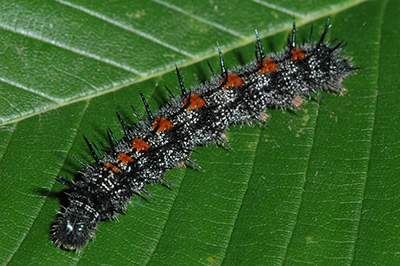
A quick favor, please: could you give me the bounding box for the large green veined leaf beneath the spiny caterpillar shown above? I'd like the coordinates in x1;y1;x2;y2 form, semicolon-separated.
0;0;400;265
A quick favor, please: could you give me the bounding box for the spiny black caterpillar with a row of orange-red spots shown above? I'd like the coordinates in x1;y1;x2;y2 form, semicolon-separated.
50;19;356;250
